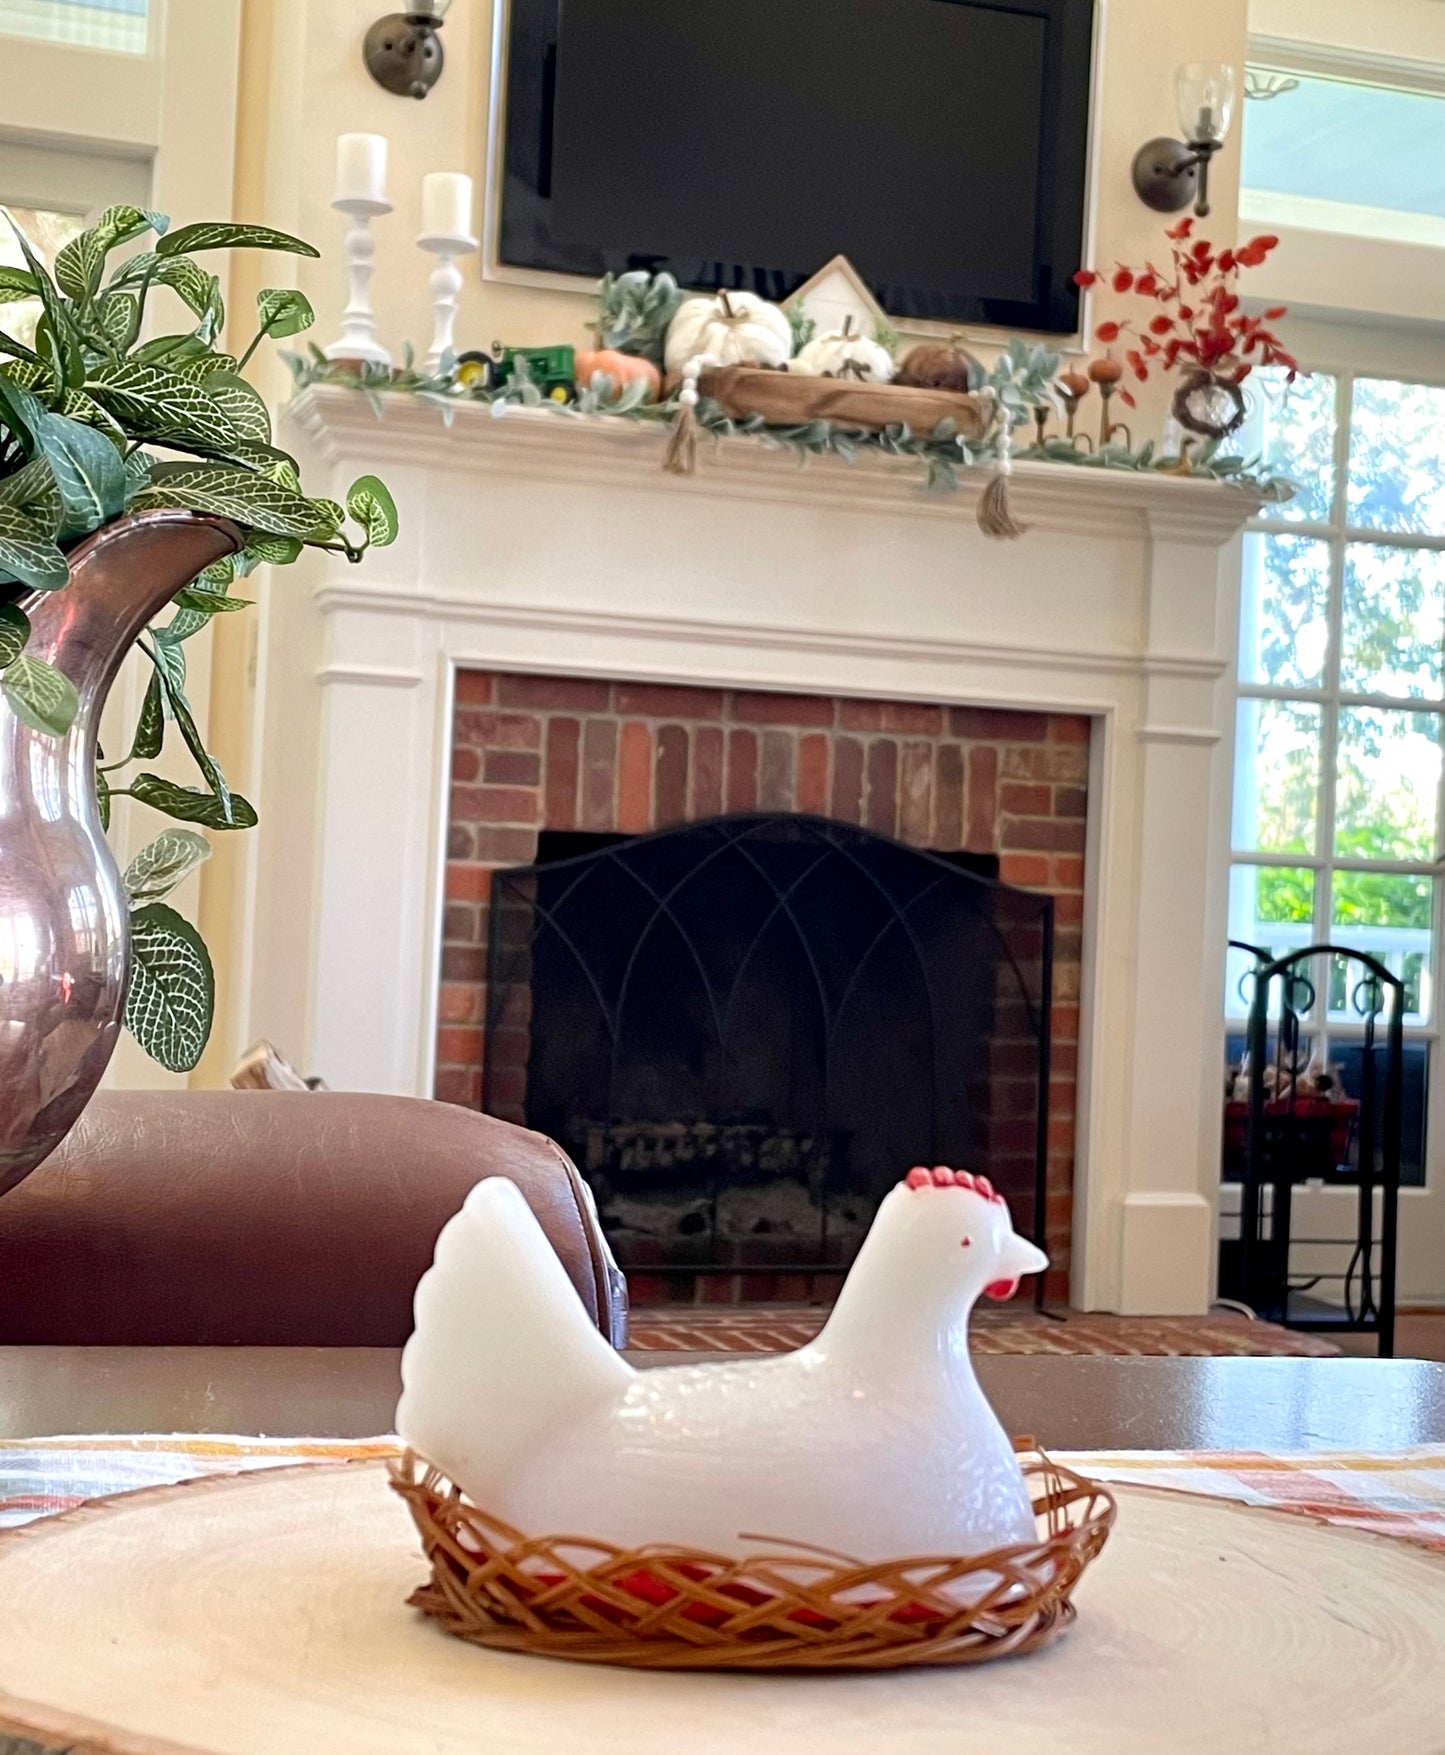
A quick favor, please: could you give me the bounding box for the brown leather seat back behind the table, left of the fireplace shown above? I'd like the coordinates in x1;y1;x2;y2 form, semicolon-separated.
0;1092;627;1346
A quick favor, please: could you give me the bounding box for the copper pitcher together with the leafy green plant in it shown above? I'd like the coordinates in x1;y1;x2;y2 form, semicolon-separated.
0;207;397;1193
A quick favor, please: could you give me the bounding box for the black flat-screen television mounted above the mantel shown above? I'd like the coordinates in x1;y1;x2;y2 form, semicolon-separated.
497;0;1094;333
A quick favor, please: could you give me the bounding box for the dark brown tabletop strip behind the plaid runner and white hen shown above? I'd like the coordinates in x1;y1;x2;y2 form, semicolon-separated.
0;1346;1445;1450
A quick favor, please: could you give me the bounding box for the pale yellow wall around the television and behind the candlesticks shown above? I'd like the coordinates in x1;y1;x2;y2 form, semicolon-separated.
195;0;1247;1083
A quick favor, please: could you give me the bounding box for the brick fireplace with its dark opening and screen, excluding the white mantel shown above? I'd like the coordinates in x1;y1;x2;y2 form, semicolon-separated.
435;670;1089;1304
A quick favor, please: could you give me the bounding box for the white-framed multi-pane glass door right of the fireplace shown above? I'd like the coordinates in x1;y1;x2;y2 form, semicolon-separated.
1226;372;1445;1179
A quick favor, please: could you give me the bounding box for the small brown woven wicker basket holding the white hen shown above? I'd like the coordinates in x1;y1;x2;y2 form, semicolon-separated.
392;1439;1115;1669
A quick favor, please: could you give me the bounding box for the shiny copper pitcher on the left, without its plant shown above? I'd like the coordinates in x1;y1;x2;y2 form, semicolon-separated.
0;511;241;1195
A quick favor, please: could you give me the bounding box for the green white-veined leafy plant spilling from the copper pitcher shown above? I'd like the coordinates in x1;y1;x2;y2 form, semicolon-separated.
0;207;397;1071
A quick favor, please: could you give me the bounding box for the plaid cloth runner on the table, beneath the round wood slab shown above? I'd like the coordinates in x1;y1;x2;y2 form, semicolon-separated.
0;1434;1445;1551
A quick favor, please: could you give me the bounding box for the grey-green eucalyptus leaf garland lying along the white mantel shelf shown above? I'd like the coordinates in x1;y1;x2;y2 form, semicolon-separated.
284;335;1294;500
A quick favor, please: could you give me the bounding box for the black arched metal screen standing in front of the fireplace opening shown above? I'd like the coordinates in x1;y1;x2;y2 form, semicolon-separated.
483;814;1053;1272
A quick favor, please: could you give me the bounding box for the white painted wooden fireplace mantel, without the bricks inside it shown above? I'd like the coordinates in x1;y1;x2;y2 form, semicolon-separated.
244;388;1257;1313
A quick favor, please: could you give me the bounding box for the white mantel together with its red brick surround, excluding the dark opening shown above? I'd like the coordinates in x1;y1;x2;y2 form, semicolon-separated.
268;386;1257;1314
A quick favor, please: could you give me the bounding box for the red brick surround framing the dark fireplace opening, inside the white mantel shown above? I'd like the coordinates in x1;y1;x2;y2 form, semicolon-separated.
435;670;1089;1302
